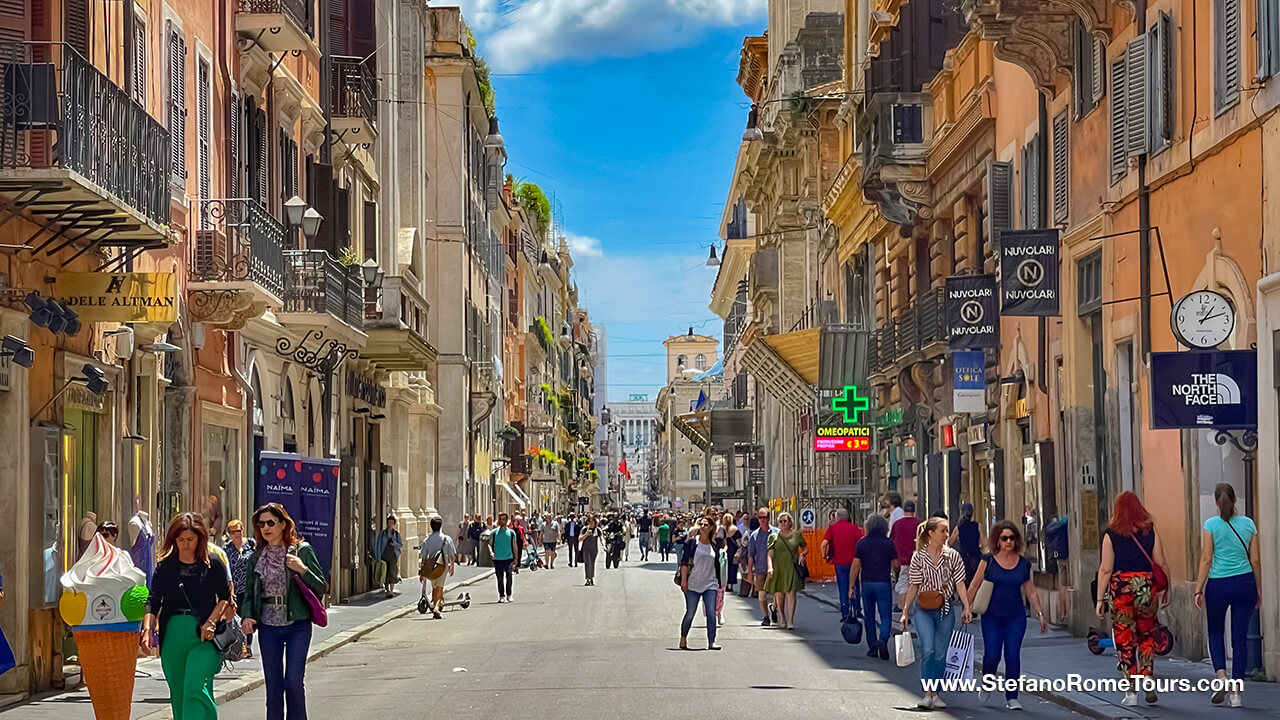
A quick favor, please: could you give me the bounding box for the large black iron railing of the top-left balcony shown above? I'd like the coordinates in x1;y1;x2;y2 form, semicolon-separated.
0;42;172;225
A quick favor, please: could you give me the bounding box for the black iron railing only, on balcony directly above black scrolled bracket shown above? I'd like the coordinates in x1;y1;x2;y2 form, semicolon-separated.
284;250;365;329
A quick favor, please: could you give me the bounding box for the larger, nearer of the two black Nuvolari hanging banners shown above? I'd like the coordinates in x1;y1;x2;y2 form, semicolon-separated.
1000;228;1061;318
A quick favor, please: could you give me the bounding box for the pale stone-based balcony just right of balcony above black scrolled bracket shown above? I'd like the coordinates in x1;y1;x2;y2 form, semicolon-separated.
360;277;435;372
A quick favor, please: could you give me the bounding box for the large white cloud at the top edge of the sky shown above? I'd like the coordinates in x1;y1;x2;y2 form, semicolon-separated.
473;0;768;72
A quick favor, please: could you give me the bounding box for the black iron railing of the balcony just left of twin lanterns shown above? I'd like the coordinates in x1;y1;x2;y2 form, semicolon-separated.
191;197;285;300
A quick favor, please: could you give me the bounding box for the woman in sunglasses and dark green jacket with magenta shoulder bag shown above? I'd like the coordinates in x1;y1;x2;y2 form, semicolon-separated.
241;502;329;720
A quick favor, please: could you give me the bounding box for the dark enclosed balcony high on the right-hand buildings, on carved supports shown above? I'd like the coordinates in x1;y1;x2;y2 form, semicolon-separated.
859;92;933;225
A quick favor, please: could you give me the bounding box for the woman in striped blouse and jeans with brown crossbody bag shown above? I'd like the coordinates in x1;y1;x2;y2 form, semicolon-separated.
901;518;973;710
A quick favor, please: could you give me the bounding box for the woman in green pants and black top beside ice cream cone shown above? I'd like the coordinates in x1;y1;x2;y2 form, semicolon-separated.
142;512;234;720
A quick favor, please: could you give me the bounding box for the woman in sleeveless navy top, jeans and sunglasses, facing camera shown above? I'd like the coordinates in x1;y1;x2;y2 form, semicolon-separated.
969;520;1048;710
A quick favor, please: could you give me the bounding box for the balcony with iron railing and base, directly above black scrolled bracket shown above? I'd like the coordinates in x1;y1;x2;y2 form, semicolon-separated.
279;250;365;345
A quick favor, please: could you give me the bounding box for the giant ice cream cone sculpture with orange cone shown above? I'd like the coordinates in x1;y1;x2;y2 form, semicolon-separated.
58;536;147;720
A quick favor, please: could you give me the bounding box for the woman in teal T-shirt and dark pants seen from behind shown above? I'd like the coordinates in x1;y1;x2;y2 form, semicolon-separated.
1196;483;1262;707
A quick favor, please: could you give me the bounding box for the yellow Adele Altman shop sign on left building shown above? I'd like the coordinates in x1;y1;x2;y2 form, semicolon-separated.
54;273;178;323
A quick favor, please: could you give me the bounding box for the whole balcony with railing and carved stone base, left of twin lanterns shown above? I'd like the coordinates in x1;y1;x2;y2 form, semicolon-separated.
187;197;287;327
